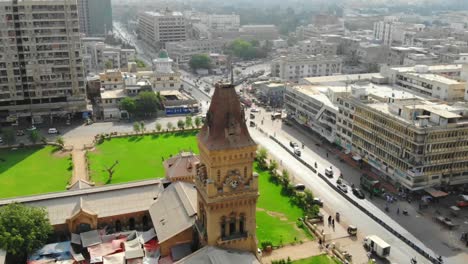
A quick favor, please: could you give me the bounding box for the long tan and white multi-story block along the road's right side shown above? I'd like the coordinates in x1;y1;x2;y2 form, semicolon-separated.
284;76;468;191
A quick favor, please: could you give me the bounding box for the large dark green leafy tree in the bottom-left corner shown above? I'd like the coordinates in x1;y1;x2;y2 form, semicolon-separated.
0;203;52;263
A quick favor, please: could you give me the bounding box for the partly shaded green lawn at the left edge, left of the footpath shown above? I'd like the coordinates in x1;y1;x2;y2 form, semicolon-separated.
0;146;72;198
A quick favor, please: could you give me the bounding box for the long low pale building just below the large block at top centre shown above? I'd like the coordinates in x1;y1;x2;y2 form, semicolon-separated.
166;39;227;63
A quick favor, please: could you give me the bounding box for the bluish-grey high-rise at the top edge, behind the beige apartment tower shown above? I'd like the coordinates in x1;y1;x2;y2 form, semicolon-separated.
77;0;112;36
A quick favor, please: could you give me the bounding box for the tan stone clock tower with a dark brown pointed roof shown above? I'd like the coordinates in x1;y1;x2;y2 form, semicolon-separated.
195;83;259;254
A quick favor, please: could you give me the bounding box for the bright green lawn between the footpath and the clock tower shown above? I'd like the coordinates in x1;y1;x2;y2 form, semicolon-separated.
88;131;198;185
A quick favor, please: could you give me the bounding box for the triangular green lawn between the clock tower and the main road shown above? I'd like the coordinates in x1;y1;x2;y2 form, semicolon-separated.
255;164;311;246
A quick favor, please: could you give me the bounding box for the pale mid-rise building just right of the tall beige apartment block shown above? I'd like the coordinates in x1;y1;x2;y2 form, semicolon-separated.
82;38;136;74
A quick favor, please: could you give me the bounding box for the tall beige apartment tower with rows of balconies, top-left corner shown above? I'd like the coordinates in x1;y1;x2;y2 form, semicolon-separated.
0;0;86;123
